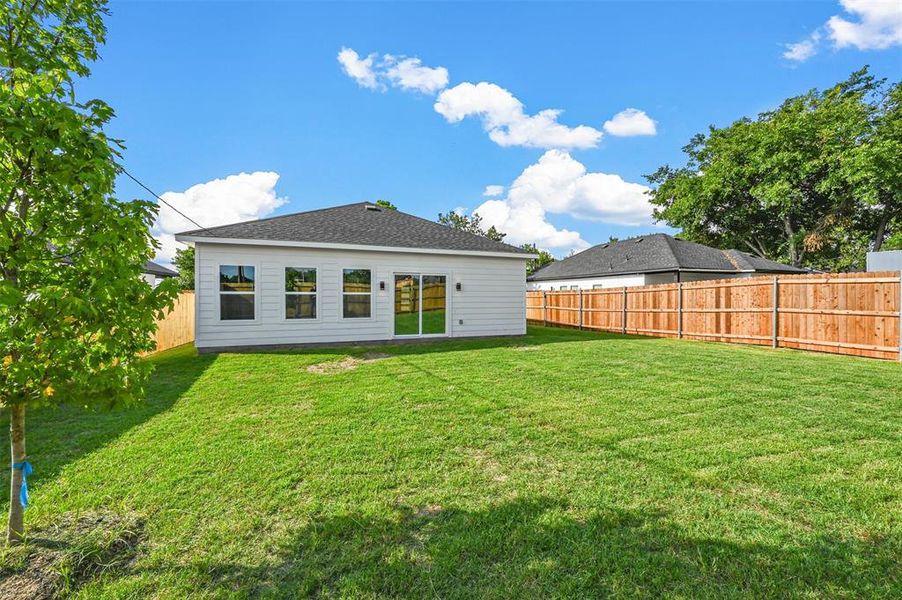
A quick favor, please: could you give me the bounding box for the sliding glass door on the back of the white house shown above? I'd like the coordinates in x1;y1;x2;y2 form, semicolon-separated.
395;273;448;336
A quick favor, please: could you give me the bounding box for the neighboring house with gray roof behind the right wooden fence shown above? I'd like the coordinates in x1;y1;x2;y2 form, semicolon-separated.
527;233;808;290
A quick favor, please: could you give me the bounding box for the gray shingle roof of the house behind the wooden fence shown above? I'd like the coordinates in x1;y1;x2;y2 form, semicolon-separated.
528;233;807;281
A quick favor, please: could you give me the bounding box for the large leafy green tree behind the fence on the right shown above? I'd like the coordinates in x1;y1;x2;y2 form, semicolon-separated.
647;68;902;270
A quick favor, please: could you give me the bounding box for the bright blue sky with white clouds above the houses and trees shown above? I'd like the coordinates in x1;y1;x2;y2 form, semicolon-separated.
80;0;902;261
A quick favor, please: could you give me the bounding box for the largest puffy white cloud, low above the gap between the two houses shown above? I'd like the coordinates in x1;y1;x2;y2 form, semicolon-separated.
473;150;652;253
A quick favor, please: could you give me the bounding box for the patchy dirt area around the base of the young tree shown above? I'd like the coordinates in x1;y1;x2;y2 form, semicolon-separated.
0;512;144;600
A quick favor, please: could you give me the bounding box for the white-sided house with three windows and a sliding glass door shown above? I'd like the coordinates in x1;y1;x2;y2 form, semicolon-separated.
176;203;535;349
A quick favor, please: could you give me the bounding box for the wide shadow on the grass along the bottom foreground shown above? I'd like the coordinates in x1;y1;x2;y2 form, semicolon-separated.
154;499;900;598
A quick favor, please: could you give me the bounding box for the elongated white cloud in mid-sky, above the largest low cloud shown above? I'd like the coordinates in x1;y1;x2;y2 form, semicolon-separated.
435;81;602;148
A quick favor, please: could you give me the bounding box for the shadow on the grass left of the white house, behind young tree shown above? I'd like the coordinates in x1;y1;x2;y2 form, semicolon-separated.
0;346;216;505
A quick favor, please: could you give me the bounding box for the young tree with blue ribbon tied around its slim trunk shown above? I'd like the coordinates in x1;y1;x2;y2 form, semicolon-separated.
0;0;176;543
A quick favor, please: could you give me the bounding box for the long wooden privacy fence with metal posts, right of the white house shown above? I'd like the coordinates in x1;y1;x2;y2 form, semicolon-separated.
526;272;902;360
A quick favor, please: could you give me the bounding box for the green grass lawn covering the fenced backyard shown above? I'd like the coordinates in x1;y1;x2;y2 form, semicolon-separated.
0;328;902;598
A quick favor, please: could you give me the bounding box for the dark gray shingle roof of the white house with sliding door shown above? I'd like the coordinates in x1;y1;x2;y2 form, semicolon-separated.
178;202;529;254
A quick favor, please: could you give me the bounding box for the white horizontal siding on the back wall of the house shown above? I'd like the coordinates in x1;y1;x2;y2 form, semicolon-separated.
195;243;526;348
